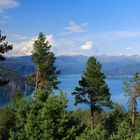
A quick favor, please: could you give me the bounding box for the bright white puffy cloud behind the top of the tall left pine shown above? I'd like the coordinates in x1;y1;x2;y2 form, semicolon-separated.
7;35;53;56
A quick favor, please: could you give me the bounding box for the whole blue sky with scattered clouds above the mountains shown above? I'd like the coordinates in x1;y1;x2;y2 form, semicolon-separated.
0;0;140;56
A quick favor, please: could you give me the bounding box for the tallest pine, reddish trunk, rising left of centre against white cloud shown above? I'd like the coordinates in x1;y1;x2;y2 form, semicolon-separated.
32;33;60;93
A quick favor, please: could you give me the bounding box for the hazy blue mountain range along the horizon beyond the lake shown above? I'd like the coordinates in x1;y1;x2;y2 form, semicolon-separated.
0;55;140;77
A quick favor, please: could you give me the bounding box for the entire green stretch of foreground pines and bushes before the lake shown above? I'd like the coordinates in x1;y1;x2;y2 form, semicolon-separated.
0;32;140;140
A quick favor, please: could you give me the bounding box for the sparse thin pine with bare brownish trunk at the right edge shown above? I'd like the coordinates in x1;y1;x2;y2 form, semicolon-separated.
124;73;140;127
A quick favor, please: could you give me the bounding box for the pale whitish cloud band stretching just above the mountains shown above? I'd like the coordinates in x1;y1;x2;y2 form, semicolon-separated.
8;31;140;56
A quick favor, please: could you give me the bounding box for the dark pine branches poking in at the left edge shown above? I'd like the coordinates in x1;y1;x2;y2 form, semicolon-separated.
0;31;12;86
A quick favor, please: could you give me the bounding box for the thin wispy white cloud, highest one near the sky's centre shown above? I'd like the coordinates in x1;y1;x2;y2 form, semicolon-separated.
61;21;88;35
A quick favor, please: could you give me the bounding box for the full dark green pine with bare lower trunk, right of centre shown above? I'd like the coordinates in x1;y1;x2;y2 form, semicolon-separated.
72;57;110;129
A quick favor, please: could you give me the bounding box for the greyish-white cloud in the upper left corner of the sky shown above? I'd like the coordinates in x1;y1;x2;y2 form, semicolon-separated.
0;0;19;12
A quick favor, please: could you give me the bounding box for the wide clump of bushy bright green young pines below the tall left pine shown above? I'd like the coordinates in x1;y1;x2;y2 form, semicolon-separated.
10;93;85;140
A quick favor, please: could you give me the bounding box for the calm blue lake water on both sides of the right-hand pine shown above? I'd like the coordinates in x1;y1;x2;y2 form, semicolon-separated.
59;74;127;110
